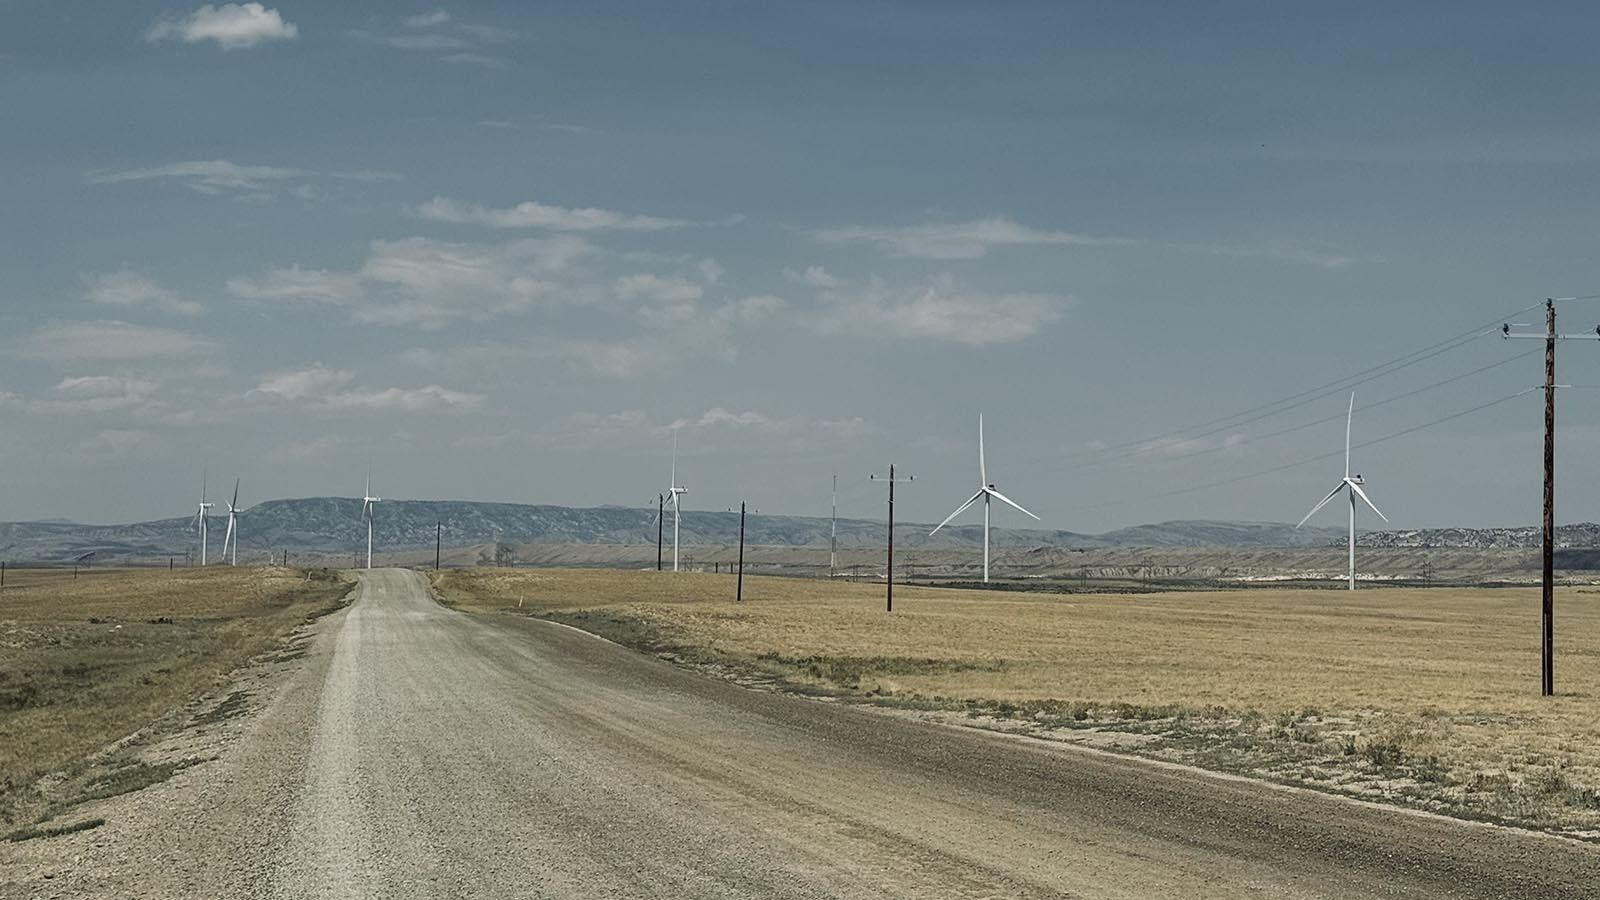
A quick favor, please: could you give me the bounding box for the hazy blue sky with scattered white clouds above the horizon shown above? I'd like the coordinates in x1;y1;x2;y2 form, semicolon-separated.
0;0;1600;532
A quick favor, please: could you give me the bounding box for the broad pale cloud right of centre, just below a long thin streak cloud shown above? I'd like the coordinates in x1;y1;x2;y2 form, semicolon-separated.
811;275;1072;346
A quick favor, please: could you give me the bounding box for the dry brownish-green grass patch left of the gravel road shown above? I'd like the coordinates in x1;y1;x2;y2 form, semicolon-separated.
0;565;349;825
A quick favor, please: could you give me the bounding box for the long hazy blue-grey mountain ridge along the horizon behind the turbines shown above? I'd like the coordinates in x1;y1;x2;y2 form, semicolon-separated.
0;496;1342;560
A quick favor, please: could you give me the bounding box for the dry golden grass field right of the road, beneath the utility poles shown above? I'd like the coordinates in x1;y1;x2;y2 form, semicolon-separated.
435;569;1600;839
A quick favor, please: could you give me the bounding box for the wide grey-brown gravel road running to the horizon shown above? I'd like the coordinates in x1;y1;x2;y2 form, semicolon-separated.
0;570;1600;900
